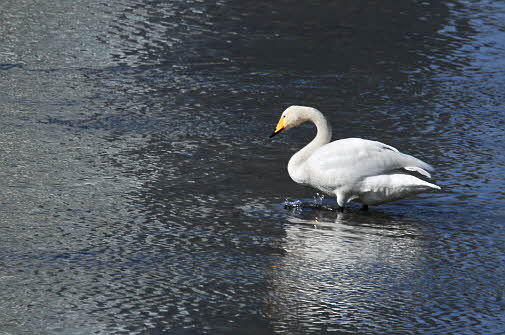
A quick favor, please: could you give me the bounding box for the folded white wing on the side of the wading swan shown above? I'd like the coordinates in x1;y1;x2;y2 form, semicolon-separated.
307;138;433;184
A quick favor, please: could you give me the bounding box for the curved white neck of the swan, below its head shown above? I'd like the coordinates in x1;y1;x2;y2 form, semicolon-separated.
288;109;331;181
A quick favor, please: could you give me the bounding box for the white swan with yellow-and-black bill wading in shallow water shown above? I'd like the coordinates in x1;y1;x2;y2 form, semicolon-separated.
270;106;440;210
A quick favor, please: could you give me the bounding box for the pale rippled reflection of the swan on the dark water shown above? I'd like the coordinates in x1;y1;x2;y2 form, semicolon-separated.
269;210;425;331
